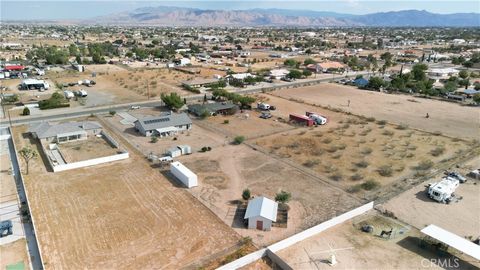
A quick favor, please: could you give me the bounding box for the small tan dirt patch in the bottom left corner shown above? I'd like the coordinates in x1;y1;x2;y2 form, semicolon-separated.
0;238;30;269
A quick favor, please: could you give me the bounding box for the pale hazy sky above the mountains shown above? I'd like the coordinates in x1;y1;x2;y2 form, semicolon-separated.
0;0;480;20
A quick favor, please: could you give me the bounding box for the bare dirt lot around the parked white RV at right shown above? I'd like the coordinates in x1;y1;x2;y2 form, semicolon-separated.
383;156;480;238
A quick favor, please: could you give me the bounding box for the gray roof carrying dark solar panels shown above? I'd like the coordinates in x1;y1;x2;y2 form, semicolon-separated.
135;113;192;130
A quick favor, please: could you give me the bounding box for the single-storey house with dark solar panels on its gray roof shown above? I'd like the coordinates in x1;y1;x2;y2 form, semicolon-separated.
134;113;192;137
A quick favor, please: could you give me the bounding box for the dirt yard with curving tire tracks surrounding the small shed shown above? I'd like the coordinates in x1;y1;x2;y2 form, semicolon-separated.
179;145;359;246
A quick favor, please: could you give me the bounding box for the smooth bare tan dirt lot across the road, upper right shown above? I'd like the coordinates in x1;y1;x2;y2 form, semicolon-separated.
273;83;480;139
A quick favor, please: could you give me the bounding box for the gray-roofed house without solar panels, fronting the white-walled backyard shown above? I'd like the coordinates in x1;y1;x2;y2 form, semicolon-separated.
28;121;102;143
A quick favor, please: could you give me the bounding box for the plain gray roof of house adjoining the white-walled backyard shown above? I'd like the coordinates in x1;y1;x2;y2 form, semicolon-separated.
28;121;102;139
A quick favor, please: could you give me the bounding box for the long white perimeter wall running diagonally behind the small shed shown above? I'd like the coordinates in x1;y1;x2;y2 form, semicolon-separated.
217;202;373;270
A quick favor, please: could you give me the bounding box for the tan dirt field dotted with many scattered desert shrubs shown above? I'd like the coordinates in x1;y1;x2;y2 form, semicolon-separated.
254;96;473;196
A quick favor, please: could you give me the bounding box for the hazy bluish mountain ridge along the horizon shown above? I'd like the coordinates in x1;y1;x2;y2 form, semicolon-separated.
82;6;480;27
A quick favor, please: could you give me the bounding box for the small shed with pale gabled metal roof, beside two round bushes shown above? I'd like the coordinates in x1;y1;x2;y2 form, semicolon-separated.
245;197;278;231
